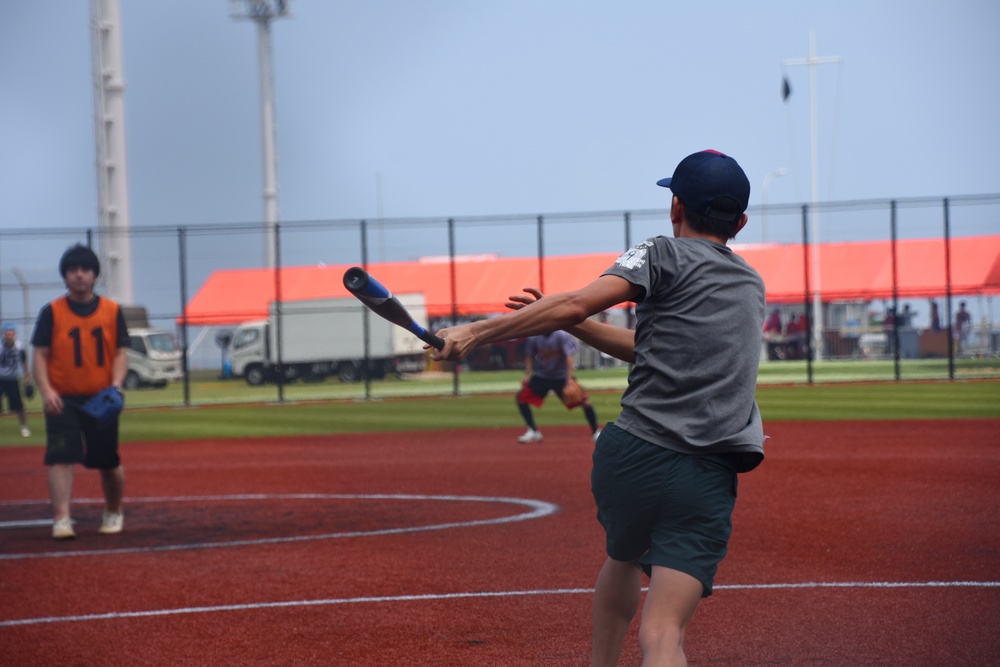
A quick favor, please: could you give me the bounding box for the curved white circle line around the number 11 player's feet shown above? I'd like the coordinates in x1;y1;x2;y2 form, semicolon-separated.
0;493;559;560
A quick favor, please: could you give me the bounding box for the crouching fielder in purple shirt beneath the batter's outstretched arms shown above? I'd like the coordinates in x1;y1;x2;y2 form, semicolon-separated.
517;331;600;443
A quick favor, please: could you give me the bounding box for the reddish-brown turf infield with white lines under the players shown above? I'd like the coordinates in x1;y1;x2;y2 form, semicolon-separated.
0;420;1000;667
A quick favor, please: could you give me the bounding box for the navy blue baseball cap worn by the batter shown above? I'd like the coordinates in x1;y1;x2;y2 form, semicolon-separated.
656;150;750;222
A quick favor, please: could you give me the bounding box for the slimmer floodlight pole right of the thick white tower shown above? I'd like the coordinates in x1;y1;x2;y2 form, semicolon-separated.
229;0;291;268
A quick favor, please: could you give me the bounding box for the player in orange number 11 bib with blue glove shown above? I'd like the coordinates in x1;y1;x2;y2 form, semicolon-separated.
31;244;129;540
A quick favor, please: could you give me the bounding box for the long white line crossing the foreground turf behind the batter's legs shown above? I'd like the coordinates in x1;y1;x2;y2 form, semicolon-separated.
0;581;1000;628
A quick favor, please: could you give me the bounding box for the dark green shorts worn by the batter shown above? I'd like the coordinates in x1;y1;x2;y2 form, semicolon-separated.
591;424;736;597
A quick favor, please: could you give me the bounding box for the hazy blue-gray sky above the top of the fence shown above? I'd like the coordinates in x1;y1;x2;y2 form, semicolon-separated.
0;0;1000;235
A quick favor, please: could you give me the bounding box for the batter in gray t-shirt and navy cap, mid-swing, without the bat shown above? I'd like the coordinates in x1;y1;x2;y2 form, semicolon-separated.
432;151;765;667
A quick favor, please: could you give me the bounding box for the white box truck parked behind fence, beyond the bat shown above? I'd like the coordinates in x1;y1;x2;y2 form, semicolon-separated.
229;294;427;385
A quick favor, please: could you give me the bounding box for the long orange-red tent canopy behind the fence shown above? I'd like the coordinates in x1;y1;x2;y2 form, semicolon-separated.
178;236;1000;326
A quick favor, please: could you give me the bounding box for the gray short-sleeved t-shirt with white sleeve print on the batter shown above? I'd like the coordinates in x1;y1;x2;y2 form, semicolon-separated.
605;236;765;472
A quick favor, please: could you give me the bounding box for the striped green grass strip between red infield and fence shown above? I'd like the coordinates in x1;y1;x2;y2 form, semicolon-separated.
0;371;1000;446
